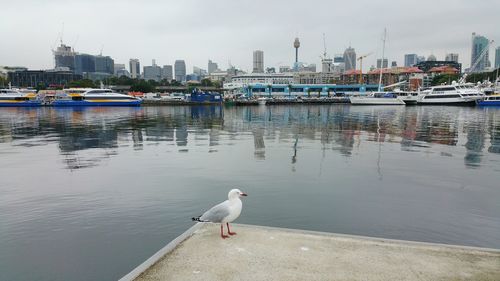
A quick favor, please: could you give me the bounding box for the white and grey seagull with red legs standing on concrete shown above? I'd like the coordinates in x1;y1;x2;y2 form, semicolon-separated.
191;189;248;239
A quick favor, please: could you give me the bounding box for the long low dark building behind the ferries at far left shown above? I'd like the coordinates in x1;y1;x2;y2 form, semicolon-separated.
8;70;83;88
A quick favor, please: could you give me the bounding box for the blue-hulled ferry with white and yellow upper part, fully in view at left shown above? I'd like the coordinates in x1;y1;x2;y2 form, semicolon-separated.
52;88;142;106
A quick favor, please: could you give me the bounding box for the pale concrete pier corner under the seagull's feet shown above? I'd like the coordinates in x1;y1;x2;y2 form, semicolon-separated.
121;224;500;281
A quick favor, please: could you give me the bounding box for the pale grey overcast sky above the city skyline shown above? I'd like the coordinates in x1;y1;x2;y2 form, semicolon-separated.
0;0;500;72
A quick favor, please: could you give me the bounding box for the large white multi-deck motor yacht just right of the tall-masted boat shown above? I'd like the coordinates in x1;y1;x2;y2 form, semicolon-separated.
418;83;484;104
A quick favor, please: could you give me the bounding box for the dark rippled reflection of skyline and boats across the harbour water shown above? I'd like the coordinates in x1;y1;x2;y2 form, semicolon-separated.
0;106;500;166
